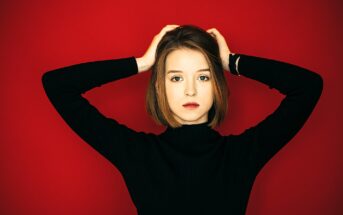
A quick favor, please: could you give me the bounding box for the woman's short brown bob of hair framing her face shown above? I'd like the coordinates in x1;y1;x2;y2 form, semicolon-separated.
146;25;230;128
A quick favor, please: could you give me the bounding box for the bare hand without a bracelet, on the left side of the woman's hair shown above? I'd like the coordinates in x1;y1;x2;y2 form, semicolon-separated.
136;25;179;72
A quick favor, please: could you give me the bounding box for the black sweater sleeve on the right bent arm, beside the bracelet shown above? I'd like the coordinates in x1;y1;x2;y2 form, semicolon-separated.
232;54;323;174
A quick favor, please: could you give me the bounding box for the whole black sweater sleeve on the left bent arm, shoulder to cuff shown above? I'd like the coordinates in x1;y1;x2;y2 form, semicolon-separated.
42;57;142;170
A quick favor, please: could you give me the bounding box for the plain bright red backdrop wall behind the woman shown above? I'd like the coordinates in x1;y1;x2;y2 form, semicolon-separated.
0;0;343;215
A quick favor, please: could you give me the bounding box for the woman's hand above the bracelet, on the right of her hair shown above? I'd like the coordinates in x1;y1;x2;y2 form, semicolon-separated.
207;28;231;71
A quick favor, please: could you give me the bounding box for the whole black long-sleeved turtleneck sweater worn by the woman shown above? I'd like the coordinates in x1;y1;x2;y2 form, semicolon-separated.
42;54;323;215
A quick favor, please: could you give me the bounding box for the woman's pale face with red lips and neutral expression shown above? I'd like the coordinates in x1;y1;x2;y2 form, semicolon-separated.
165;49;213;124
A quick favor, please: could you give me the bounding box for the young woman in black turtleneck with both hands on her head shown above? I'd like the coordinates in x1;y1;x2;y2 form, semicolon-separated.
42;25;323;215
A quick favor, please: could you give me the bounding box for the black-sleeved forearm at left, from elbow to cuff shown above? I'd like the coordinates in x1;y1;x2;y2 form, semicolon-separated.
42;57;138;95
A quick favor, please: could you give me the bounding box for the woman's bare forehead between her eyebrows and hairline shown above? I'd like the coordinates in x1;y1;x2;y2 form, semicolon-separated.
165;48;209;71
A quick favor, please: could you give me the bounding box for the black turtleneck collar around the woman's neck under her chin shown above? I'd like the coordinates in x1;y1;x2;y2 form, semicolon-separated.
160;122;220;146
